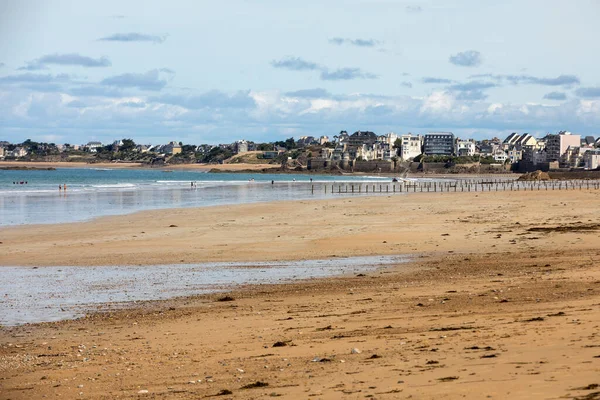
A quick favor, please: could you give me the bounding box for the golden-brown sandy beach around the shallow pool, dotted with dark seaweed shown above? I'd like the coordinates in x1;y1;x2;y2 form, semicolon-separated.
0;191;600;399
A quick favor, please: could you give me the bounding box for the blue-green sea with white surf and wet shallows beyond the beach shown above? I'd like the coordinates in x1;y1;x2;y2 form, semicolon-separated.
0;168;391;226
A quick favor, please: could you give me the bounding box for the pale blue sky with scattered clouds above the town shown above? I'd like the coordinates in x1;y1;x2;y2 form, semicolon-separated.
0;0;600;144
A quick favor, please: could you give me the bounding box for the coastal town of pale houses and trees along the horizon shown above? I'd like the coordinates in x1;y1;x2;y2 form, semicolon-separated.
0;131;600;172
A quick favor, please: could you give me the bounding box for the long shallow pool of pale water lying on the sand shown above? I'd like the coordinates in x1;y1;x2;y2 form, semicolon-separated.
0;256;408;326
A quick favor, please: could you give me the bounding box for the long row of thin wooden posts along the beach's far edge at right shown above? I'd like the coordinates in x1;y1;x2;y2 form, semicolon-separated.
311;180;600;194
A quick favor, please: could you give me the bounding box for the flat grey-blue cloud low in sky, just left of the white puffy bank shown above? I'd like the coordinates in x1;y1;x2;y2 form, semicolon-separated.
149;90;256;110
